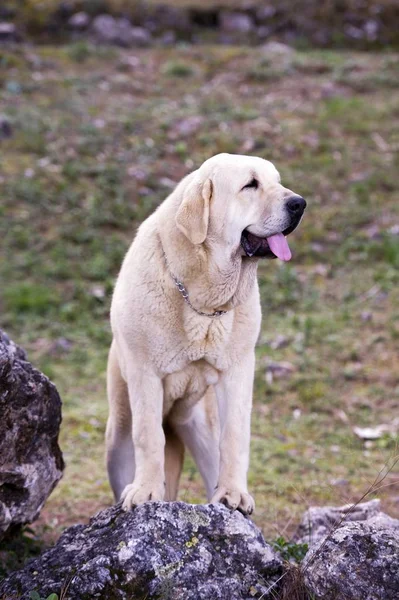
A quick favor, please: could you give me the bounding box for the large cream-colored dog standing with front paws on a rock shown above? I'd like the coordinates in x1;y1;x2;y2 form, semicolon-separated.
106;154;306;514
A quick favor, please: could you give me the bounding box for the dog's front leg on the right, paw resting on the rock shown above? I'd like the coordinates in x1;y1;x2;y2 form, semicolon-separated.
211;352;255;514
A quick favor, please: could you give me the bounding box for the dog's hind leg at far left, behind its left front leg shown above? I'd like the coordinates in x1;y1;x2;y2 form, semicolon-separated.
106;342;135;501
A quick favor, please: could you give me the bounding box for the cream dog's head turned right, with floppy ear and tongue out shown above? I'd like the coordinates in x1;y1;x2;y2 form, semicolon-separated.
176;154;306;260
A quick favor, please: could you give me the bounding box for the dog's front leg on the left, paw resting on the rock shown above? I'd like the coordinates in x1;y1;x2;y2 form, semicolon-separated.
121;365;165;510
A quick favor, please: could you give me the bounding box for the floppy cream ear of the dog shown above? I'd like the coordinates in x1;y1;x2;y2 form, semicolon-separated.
176;179;212;244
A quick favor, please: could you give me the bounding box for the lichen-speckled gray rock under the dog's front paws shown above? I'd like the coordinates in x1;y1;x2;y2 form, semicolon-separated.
0;502;282;600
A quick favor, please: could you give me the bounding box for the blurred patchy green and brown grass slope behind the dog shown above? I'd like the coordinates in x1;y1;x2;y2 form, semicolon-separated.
0;43;399;572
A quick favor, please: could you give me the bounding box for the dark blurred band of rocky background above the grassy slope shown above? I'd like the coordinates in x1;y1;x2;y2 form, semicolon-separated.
0;0;399;49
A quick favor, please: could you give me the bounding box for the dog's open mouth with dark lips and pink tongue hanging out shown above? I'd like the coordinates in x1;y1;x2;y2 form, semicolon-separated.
241;221;299;261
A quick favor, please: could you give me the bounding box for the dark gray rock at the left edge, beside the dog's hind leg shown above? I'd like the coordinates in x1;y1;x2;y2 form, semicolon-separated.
0;330;64;539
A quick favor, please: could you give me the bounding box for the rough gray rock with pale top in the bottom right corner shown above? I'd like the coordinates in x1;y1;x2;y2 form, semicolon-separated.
296;500;399;600
